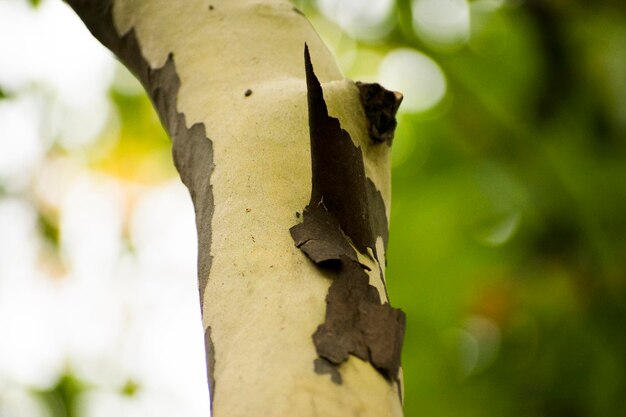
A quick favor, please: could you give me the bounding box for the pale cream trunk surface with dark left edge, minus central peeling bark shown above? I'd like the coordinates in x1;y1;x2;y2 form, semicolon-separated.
68;0;402;417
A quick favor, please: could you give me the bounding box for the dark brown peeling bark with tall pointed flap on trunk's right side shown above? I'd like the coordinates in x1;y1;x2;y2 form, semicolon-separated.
290;47;405;382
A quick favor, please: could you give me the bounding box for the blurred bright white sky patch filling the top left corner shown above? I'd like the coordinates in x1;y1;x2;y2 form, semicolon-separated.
0;0;115;150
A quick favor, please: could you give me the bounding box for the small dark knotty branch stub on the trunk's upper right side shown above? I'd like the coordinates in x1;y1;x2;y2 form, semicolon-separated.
356;82;402;146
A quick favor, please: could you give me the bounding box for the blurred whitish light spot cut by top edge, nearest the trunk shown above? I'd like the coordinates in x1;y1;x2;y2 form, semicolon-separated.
317;0;394;40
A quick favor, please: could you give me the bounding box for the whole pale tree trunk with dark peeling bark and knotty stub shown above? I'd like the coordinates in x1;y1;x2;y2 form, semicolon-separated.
67;0;404;417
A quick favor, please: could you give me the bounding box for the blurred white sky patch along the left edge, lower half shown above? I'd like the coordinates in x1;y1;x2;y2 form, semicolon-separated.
0;198;63;391
